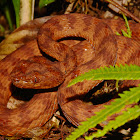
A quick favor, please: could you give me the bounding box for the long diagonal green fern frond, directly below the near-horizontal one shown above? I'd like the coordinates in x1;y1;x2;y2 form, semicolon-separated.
66;87;140;140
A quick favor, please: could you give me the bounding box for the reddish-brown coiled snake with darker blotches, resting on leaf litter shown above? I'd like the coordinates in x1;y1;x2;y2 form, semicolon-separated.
0;14;140;136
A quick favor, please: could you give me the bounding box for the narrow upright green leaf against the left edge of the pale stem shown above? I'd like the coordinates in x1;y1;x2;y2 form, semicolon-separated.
12;0;20;28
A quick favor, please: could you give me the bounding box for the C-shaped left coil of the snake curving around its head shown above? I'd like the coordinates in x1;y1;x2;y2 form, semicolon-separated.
0;40;57;136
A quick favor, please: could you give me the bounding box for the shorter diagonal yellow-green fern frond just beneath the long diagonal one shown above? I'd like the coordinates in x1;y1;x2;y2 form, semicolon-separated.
85;105;140;140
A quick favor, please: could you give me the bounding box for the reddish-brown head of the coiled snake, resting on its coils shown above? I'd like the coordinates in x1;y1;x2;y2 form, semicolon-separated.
10;57;64;89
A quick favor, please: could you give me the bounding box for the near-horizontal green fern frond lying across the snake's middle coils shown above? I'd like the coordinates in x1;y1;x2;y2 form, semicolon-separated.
68;64;140;87
